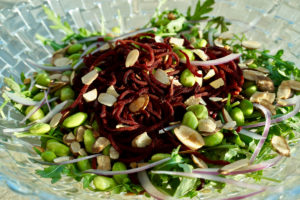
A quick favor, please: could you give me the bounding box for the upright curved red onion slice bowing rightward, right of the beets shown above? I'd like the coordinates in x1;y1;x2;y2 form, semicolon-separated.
250;103;271;163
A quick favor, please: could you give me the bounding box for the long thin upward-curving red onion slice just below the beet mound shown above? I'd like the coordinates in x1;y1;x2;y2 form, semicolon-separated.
84;158;171;176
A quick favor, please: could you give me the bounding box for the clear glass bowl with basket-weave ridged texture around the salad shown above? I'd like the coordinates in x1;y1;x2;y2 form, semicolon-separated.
0;0;300;200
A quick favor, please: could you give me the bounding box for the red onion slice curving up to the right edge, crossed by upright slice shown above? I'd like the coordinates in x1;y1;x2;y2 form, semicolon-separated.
243;96;300;128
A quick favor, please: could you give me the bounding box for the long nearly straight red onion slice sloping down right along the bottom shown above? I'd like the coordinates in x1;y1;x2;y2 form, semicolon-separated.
151;171;267;190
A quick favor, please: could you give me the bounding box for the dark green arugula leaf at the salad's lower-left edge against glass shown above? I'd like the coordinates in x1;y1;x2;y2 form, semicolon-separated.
35;165;65;184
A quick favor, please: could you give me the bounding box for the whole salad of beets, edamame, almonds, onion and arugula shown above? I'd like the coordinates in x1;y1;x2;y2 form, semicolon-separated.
0;0;300;199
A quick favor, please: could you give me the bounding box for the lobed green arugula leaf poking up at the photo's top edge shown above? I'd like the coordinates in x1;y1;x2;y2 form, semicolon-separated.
186;0;215;21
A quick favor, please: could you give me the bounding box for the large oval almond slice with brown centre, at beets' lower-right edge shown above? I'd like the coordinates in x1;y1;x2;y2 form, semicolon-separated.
174;125;205;150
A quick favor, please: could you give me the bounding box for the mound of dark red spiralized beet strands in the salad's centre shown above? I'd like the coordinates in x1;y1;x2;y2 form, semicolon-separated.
67;33;244;162
